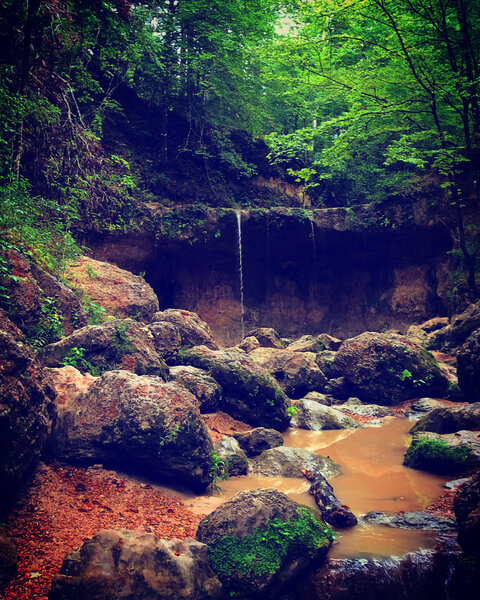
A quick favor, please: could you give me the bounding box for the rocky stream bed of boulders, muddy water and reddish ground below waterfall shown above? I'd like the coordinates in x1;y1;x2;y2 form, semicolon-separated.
0;255;480;600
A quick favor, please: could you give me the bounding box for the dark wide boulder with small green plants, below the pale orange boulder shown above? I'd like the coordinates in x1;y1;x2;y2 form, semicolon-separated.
39;319;168;378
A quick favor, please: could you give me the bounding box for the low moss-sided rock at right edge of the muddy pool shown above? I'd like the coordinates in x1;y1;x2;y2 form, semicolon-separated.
403;430;480;474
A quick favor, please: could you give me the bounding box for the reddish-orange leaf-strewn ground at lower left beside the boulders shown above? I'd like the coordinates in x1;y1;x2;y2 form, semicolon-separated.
0;463;202;600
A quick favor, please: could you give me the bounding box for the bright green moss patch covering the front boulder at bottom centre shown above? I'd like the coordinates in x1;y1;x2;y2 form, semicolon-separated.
208;507;333;577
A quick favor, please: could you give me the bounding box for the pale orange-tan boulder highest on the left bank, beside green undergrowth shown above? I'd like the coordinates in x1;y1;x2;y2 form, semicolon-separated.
66;256;158;323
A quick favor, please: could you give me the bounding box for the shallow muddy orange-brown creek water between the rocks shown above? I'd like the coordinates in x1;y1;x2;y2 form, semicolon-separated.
172;419;447;558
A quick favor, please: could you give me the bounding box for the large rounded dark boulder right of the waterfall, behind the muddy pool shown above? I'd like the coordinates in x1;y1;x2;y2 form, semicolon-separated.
334;332;449;405
